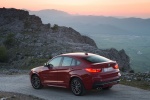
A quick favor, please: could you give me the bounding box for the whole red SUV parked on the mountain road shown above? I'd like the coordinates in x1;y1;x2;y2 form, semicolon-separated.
30;53;121;96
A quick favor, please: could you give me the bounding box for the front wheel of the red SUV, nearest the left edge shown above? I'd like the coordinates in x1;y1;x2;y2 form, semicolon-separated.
31;75;43;89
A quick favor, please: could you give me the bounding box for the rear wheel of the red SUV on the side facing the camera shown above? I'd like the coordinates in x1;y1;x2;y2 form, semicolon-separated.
70;78;86;96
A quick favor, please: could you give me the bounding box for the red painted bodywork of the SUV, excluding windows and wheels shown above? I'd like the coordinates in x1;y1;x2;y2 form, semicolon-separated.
30;53;121;90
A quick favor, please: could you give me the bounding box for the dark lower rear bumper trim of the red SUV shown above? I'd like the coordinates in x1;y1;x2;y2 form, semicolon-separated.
93;78;120;89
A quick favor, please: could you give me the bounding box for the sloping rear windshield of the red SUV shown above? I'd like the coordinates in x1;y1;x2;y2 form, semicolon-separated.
84;55;111;63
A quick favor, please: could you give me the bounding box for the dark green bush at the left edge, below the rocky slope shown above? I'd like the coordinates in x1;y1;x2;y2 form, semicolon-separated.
0;46;8;62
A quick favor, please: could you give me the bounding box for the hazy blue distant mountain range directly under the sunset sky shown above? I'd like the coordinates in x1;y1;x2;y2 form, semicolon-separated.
29;10;150;35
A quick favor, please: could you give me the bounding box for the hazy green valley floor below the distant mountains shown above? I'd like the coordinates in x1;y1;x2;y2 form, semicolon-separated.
90;34;150;72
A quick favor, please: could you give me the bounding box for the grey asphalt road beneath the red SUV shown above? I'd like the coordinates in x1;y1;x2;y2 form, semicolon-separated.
0;75;150;100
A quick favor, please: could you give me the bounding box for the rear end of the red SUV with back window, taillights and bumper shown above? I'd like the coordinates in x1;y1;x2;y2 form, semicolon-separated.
83;54;121;89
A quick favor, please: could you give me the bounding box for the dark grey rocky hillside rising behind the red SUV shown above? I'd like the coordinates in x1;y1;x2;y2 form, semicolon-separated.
0;8;131;70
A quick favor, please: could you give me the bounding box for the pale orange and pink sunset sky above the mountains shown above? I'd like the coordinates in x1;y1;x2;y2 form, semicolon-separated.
0;0;150;18
